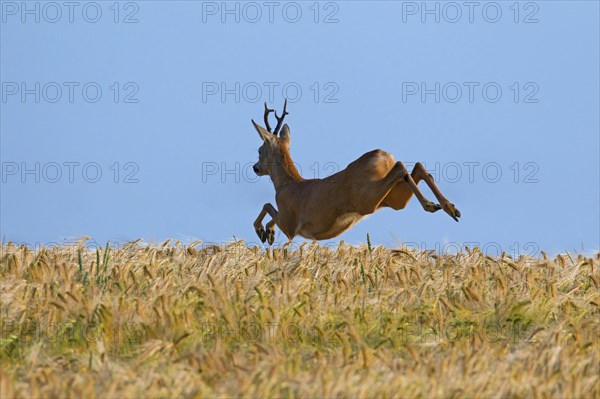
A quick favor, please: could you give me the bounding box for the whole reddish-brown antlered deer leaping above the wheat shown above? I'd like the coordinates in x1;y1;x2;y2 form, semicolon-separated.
252;99;460;245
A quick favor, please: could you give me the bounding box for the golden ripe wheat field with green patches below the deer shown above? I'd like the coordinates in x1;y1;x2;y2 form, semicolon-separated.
0;240;600;398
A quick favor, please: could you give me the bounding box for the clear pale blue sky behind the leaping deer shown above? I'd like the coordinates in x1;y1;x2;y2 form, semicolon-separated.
0;1;600;255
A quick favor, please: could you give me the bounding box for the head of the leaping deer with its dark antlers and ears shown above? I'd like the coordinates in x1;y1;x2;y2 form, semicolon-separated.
252;99;290;176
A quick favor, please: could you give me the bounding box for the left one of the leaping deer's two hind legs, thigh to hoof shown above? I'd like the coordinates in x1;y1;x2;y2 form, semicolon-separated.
366;161;442;213
